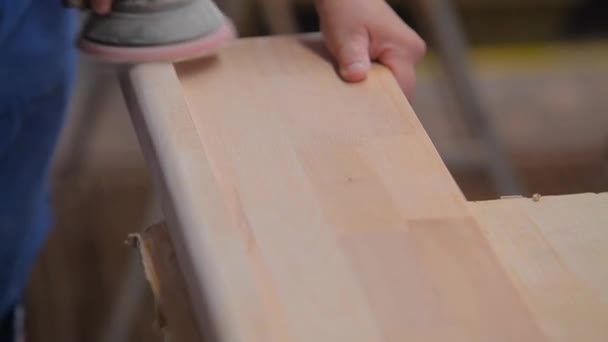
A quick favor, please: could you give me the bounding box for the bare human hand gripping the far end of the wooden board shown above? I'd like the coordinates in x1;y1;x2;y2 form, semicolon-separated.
315;0;426;95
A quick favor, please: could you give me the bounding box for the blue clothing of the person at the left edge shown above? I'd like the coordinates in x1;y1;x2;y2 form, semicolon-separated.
0;0;77;317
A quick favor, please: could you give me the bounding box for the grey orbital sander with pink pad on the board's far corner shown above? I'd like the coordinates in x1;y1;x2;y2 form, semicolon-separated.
64;0;236;63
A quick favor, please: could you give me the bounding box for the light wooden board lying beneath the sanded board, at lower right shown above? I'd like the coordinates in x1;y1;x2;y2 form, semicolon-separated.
472;193;608;342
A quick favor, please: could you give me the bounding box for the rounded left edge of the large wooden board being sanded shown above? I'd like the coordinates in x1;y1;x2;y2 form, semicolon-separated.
119;63;240;341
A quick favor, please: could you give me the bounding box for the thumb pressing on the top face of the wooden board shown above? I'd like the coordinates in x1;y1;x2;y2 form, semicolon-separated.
335;33;371;82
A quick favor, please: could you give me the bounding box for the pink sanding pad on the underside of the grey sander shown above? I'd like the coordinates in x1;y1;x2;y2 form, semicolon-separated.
78;21;236;63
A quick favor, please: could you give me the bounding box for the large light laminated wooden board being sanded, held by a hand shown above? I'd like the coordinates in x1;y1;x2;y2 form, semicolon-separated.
123;36;545;342
